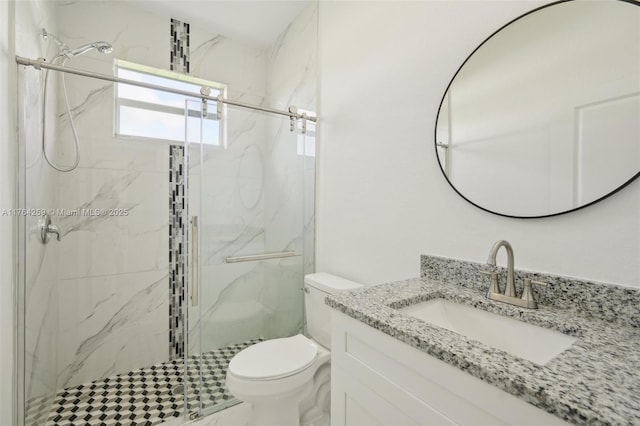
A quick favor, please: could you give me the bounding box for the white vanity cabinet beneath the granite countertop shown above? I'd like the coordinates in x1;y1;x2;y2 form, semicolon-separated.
331;310;568;426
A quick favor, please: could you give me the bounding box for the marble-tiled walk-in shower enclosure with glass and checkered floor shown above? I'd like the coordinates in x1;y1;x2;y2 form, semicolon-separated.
17;1;316;425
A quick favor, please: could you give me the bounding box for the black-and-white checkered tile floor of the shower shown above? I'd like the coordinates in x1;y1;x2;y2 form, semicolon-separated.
37;339;261;426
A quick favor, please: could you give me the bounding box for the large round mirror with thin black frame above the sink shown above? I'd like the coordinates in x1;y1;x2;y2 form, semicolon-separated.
435;0;640;218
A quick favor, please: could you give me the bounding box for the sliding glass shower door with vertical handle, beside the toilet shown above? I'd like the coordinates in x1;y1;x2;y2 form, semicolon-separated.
185;101;305;414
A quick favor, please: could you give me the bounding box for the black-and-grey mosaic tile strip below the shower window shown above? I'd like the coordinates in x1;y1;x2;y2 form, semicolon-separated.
169;145;187;360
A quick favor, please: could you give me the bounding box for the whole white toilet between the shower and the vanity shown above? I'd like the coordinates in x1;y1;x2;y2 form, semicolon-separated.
227;273;362;426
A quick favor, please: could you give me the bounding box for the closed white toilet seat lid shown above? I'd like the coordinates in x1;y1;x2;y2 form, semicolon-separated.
229;334;318;380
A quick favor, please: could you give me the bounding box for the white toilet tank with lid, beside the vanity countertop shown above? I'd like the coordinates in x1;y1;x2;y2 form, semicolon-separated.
304;272;362;349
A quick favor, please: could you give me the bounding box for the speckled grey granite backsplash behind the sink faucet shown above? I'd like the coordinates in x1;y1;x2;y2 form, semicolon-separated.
420;255;640;327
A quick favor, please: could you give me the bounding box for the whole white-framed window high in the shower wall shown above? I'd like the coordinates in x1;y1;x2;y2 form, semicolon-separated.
115;60;226;147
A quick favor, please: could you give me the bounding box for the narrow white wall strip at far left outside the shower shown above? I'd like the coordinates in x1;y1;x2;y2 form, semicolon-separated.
0;1;16;425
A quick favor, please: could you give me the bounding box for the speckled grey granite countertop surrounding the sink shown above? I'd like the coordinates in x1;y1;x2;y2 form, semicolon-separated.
326;278;640;425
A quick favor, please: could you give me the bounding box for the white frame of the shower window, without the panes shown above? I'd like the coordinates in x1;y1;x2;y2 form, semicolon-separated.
114;59;227;149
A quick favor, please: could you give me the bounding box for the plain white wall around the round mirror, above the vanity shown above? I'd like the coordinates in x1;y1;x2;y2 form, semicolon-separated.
317;0;640;287
